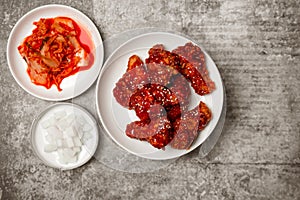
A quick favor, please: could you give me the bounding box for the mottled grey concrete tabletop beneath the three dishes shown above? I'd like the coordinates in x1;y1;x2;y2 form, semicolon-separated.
0;0;300;199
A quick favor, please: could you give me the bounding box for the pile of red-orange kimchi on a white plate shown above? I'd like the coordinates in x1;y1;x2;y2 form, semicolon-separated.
18;17;94;91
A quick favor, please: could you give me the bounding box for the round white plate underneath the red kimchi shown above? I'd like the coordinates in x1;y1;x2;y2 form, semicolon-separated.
7;4;104;101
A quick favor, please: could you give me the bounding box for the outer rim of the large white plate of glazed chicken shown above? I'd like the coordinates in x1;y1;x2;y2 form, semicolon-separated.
95;31;225;160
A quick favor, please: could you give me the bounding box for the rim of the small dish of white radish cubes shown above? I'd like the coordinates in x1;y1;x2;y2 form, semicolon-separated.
30;102;99;170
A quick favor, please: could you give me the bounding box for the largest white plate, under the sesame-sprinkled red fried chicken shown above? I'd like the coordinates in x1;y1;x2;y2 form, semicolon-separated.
96;32;224;160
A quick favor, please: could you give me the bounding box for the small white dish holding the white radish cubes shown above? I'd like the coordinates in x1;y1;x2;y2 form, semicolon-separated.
30;103;99;170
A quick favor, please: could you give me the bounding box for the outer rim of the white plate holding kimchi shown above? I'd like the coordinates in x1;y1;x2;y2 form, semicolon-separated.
6;3;105;102
